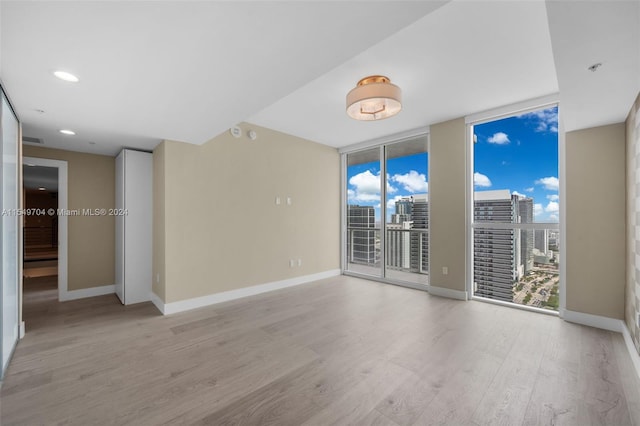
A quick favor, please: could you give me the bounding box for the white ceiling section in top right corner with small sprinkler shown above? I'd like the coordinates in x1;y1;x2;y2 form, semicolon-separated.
548;0;640;131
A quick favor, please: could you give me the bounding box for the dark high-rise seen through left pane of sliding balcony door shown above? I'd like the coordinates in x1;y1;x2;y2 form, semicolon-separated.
347;205;376;264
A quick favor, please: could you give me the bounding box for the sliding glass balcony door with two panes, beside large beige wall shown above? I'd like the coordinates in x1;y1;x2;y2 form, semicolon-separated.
344;135;429;285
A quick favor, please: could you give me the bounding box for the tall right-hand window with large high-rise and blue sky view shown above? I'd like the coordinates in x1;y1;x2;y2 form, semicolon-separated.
470;105;562;311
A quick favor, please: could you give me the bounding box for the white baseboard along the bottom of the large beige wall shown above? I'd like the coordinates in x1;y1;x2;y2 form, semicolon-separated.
151;269;340;315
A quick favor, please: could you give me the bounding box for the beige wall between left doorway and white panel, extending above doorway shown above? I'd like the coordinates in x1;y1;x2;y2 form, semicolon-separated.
23;145;115;291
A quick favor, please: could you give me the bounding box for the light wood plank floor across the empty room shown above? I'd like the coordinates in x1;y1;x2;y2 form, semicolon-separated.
0;277;640;426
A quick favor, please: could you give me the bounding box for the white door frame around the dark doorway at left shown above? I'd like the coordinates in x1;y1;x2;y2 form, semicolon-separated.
22;157;69;302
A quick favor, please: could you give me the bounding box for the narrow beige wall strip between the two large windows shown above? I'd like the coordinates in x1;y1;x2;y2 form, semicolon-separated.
429;118;467;291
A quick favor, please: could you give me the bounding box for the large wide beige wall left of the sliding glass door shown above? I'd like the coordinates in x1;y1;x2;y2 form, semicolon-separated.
154;124;340;303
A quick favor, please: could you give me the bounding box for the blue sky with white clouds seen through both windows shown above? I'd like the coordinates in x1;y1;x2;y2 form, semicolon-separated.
347;107;559;222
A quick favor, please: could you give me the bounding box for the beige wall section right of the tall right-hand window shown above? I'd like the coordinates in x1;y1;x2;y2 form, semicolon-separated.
561;123;626;319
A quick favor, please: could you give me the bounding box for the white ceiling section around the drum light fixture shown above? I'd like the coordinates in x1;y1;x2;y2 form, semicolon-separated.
248;2;558;147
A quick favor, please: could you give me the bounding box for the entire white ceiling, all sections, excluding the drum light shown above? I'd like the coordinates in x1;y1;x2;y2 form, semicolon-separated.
0;0;640;155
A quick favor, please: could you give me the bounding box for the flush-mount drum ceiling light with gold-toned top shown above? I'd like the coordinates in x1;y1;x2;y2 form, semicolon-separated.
347;75;402;121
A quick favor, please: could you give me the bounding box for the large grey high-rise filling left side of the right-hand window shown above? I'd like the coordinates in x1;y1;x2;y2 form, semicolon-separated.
473;189;533;302
